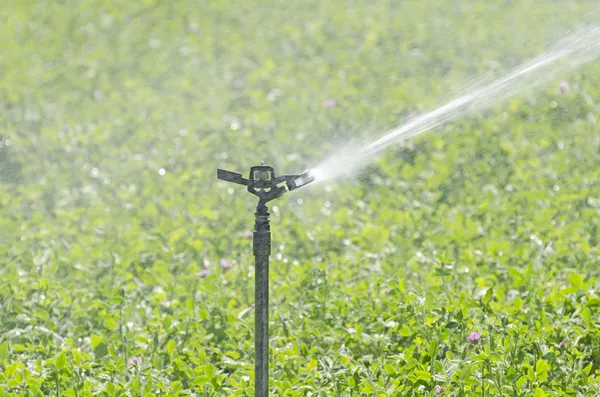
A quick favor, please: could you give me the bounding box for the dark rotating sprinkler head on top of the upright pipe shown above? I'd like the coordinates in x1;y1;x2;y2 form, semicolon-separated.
217;162;315;204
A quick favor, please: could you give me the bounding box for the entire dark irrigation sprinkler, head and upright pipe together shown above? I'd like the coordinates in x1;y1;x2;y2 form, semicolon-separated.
217;161;315;397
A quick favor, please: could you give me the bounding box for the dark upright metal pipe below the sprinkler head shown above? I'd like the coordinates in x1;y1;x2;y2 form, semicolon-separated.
253;202;271;397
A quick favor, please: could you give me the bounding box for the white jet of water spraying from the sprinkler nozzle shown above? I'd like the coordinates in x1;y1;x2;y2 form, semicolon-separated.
311;23;600;182
